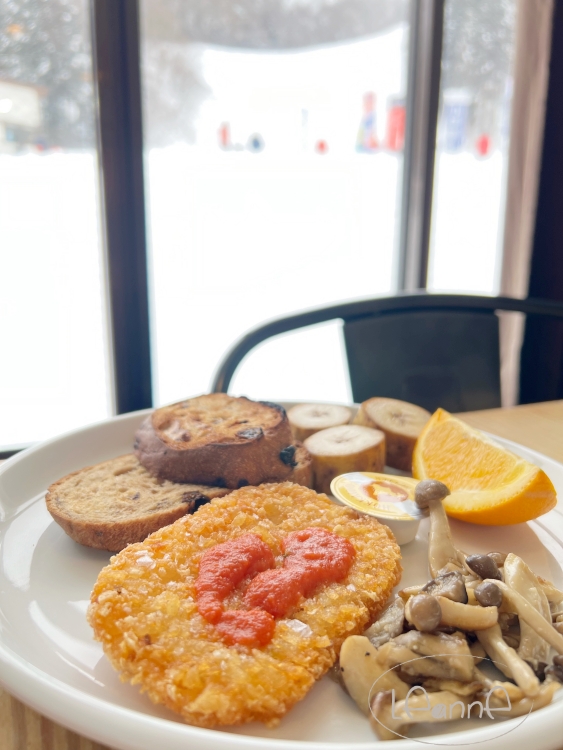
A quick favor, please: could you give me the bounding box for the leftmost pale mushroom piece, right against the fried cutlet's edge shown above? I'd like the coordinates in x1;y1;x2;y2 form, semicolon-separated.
340;635;409;716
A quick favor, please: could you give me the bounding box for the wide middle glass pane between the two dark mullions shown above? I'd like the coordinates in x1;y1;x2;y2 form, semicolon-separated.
141;0;409;402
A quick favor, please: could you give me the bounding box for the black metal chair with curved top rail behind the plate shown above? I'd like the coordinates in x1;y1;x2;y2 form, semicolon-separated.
209;292;563;412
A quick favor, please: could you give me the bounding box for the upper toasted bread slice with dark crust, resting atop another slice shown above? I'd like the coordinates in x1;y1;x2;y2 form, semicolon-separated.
134;393;297;488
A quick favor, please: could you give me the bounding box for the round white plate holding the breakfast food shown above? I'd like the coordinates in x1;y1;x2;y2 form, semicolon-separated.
0;412;563;750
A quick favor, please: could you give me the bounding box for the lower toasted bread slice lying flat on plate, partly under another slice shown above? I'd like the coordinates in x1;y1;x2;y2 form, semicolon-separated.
45;454;229;552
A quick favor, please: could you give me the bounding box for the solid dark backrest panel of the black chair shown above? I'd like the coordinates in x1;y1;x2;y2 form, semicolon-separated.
344;310;501;411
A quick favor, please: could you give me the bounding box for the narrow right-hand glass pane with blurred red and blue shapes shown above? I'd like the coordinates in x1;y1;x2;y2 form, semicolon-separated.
428;0;517;294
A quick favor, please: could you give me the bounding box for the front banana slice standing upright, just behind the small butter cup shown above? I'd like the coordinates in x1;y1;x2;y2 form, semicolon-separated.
305;424;385;493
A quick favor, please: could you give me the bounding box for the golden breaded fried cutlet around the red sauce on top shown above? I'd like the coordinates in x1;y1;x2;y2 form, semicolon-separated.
88;482;401;727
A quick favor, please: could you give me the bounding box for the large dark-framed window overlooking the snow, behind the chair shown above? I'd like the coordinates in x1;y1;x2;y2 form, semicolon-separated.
0;0;548;452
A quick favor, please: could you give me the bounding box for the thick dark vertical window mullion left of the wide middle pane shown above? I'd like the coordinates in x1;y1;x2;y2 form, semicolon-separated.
92;0;152;414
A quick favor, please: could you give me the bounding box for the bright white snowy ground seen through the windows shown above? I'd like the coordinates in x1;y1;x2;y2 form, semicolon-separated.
0;150;503;445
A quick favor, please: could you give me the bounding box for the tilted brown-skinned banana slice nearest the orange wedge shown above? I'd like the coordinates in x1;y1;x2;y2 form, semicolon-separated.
354;398;431;471
